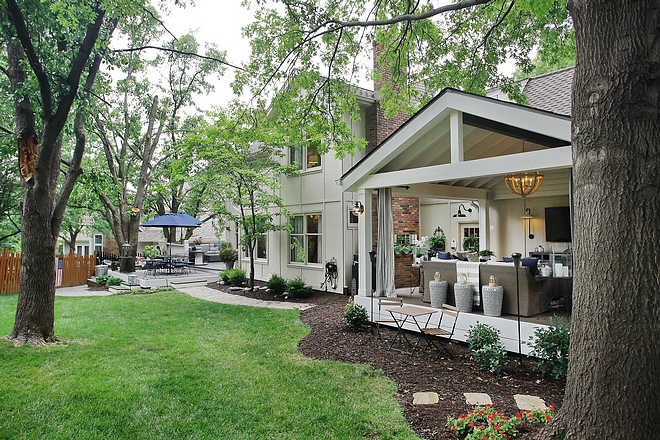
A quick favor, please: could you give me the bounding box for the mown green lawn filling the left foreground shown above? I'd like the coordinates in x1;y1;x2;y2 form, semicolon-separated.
0;292;416;440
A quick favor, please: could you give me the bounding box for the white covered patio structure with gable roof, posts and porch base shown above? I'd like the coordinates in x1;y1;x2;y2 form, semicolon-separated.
337;89;572;352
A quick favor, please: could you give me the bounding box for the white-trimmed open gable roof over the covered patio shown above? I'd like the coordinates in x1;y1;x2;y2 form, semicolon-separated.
337;89;571;198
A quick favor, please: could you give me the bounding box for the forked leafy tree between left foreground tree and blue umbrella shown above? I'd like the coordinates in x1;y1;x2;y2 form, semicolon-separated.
89;28;224;272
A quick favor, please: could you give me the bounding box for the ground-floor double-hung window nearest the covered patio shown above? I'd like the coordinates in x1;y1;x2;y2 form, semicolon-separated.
290;214;322;264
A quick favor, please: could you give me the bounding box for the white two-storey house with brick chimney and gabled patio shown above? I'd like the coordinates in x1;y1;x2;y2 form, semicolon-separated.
236;69;572;294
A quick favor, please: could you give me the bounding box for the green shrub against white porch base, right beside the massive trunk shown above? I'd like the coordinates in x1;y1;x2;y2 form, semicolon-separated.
526;317;571;379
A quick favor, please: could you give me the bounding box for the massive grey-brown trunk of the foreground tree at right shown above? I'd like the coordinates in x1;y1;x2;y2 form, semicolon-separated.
554;0;660;440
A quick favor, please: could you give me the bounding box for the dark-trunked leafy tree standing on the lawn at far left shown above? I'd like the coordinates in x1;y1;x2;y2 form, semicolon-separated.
0;0;196;345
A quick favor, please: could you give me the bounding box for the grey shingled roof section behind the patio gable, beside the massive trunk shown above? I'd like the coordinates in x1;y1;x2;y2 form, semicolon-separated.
523;67;575;116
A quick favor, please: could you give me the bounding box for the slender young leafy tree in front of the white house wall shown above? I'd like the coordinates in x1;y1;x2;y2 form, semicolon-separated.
185;102;297;287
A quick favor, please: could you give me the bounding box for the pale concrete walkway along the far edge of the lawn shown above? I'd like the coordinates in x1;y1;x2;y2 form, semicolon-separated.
55;285;314;310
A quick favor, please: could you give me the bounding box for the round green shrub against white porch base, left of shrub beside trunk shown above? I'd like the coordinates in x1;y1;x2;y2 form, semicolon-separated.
467;322;507;374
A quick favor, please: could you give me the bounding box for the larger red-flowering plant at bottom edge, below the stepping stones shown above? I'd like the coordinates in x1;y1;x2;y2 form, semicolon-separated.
446;405;521;440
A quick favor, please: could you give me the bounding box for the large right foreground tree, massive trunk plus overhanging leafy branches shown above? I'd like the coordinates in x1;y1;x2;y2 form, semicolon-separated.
238;0;660;439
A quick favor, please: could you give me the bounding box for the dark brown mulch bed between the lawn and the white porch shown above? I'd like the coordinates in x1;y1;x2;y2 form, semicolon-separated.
209;283;565;439
